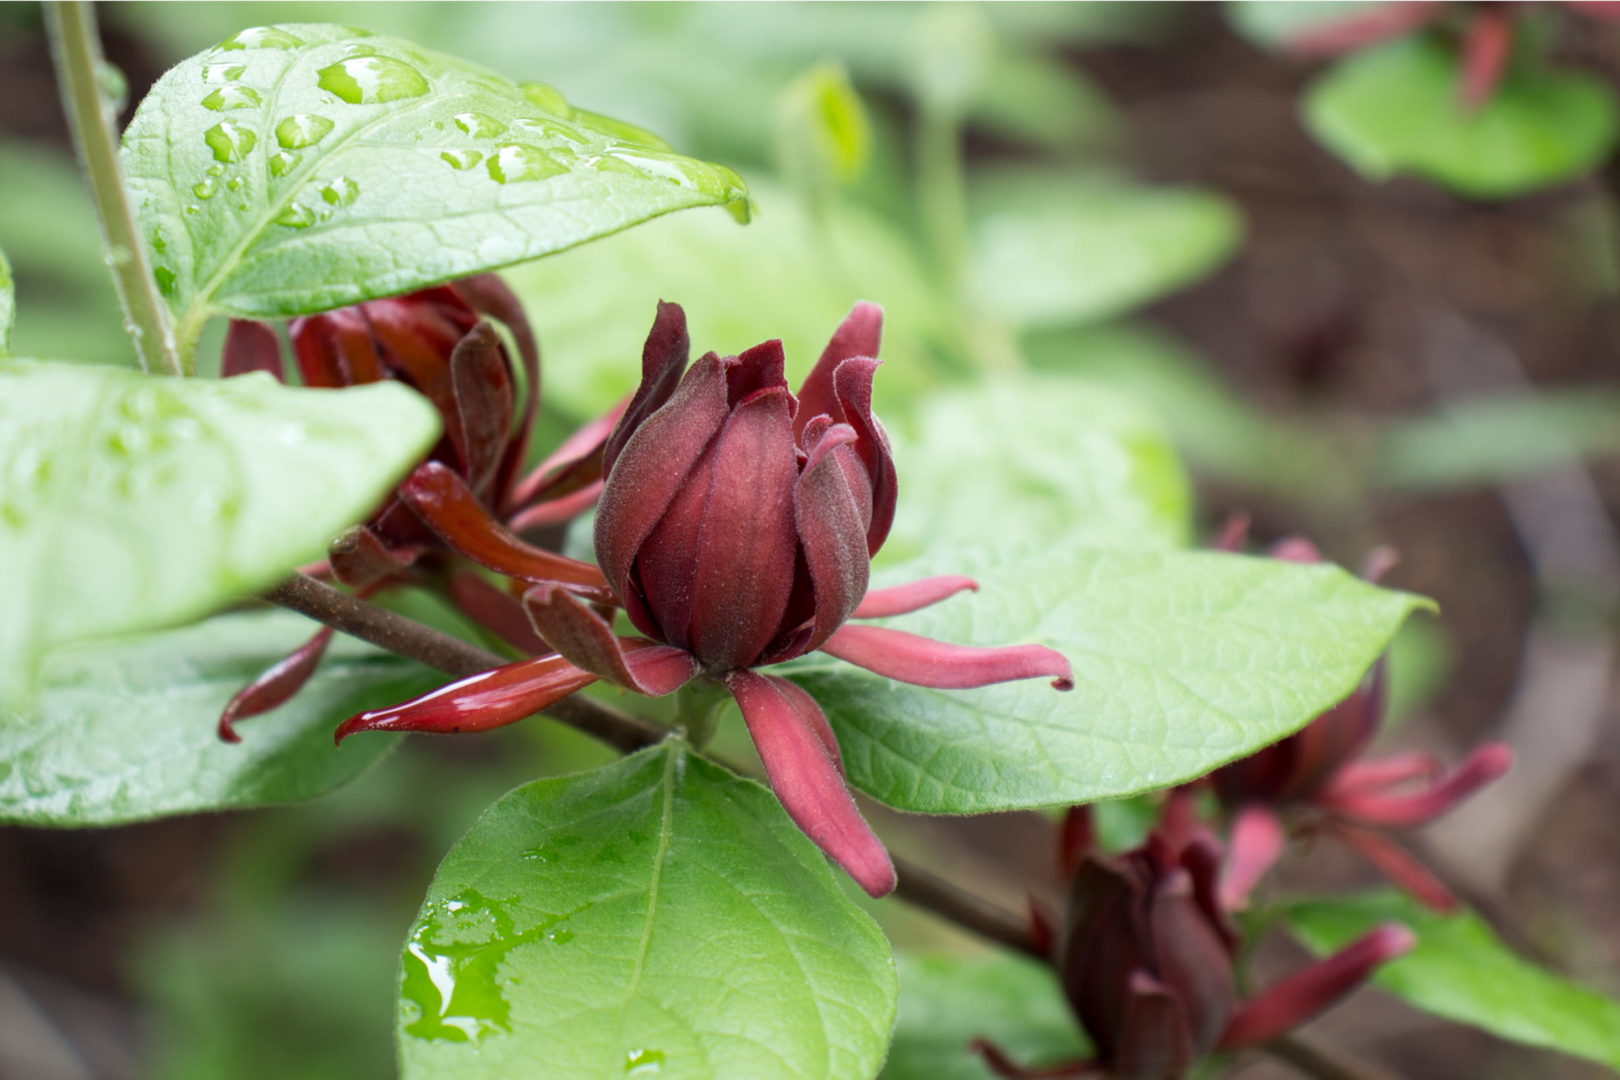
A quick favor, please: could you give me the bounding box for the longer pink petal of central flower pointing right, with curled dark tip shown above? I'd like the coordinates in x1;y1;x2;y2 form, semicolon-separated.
821;625;1074;690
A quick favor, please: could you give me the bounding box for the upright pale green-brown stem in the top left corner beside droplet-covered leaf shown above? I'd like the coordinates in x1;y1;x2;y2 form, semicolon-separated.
45;0;185;376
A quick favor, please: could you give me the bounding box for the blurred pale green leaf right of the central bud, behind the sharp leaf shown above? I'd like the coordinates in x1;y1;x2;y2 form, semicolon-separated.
885;376;1192;566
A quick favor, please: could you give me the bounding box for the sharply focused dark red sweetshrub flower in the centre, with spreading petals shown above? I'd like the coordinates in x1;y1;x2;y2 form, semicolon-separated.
339;304;1072;895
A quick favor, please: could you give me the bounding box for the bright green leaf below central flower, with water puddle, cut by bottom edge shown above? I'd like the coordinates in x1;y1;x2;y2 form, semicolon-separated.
400;740;896;1080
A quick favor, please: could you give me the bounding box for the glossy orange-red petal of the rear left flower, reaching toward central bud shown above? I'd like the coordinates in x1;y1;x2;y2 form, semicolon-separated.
399;461;614;604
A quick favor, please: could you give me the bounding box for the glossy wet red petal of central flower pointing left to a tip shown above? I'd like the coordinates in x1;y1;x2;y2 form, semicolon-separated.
335;656;596;742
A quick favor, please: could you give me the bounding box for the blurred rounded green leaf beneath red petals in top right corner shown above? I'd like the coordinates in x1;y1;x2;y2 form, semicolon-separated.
1304;36;1620;199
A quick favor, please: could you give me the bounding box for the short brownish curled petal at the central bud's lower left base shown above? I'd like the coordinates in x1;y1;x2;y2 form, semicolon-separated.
523;585;698;698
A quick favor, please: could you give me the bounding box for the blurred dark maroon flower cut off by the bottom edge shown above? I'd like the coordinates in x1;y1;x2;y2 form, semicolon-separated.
974;792;1414;1080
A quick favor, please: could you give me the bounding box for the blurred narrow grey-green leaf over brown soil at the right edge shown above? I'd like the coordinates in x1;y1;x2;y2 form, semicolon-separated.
1374;387;1620;489
